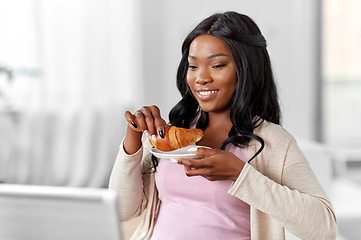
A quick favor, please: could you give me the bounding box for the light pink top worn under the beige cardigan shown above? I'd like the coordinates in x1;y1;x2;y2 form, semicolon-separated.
151;145;251;240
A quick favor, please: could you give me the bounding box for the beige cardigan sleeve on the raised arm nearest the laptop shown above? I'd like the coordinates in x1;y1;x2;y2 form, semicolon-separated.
109;139;150;221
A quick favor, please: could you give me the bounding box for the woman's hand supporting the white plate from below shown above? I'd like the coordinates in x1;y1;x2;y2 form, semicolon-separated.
177;148;245;181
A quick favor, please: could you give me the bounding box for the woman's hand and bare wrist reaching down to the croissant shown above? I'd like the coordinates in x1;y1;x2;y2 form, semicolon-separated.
124;105;167;154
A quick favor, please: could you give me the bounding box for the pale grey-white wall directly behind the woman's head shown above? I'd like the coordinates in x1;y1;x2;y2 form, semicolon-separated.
138;0;318;142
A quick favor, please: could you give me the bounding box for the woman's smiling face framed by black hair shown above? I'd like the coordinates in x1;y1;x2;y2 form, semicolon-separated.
187;35;237;113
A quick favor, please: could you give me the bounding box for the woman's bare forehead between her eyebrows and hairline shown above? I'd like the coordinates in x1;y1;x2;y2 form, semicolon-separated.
189;35;230;57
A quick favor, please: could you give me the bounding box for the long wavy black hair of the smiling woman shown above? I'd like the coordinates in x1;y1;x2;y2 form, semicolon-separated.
169;12;280;161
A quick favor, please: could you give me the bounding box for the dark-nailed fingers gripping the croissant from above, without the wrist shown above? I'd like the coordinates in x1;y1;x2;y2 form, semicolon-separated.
125;105;167;137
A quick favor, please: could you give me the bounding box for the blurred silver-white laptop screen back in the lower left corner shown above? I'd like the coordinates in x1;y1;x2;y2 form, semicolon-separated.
0;184;122;240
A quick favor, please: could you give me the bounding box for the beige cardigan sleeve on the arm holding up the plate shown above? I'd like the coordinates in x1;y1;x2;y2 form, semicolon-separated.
229;137;337;240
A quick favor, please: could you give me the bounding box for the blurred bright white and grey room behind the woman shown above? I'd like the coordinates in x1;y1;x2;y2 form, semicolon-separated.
0;0;361;240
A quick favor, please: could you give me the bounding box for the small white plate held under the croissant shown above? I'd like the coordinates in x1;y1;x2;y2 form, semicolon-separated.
150;145;211;160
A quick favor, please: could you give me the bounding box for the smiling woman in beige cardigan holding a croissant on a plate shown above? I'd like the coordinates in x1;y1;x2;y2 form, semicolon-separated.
110;12;337;239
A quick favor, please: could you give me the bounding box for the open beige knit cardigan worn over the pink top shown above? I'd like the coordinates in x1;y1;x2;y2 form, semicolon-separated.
109;121;337;240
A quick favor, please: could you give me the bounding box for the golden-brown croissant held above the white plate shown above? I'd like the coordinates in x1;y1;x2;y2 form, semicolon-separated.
148;126;203;151
